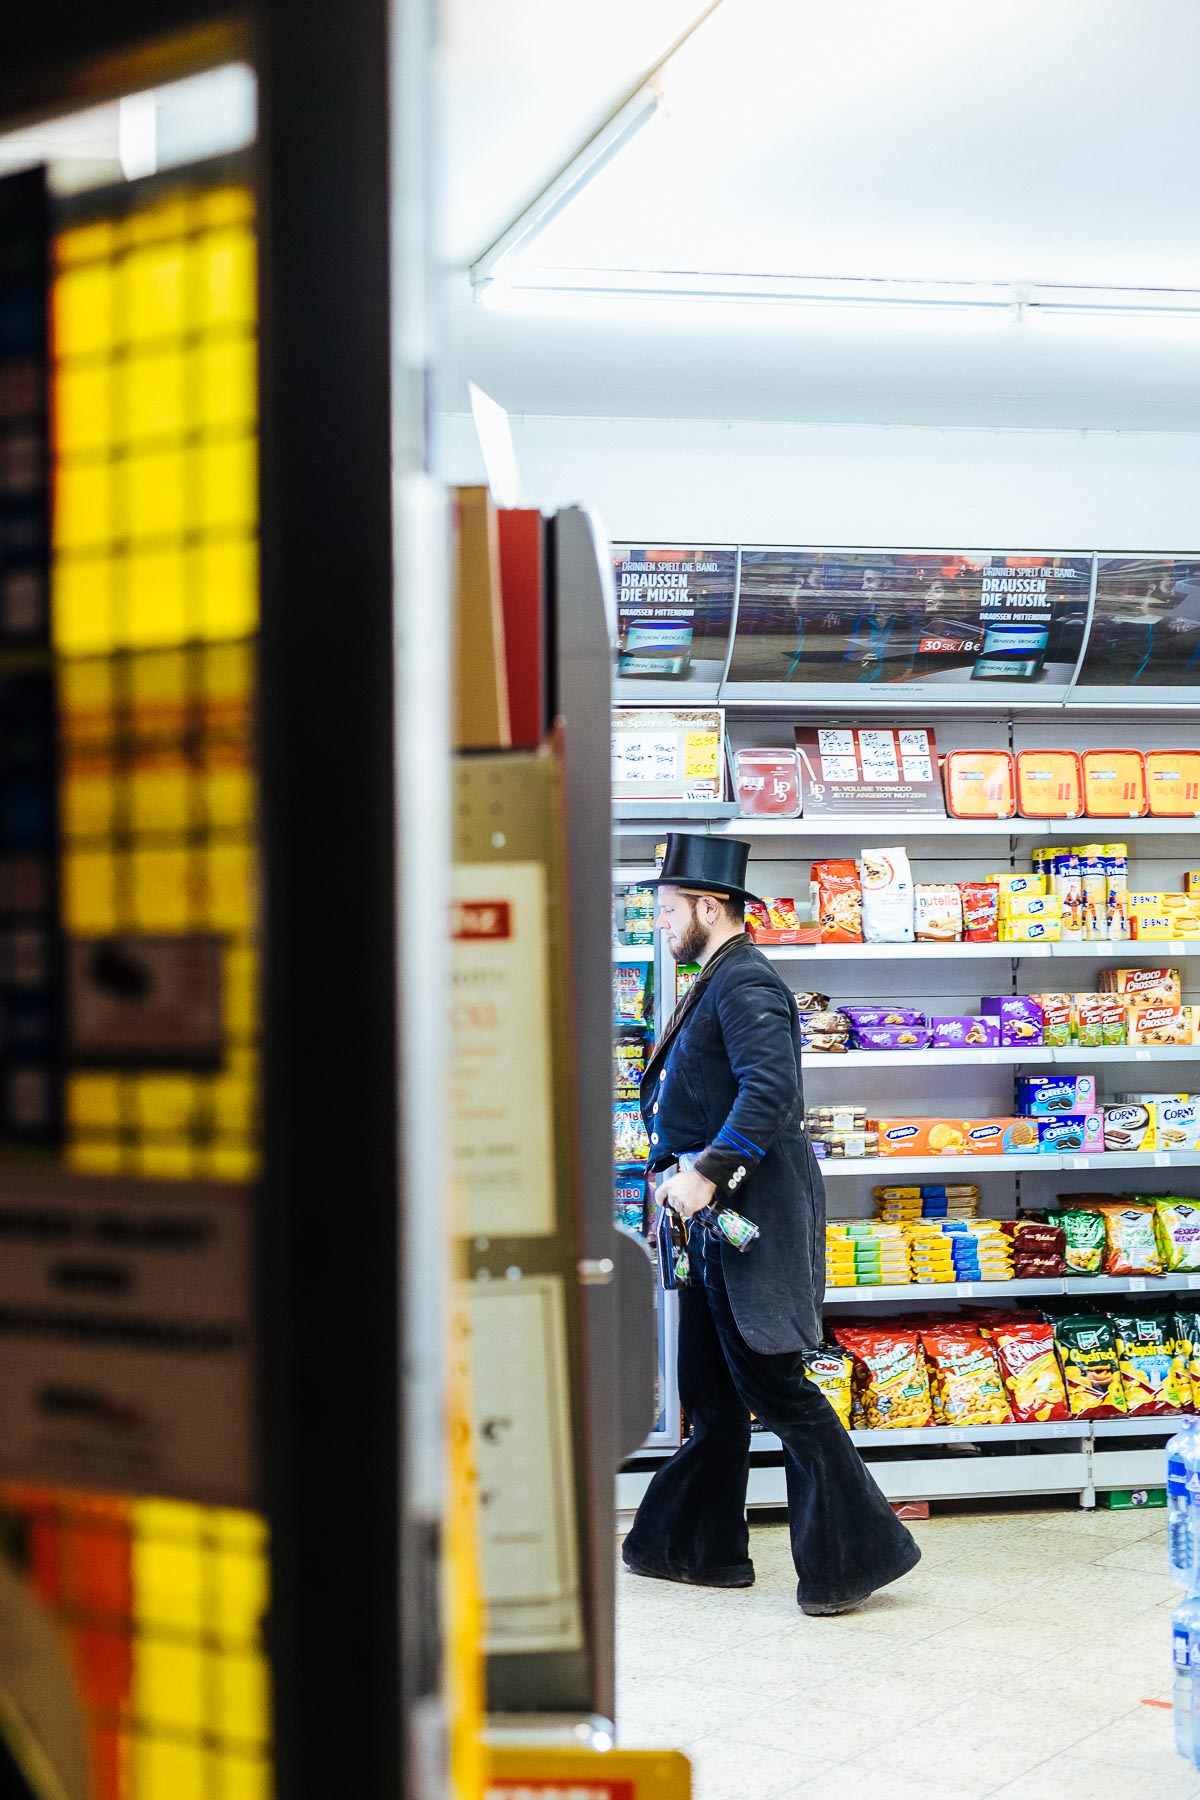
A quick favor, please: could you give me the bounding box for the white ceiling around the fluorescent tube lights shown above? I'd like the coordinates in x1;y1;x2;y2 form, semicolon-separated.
444;0;1200;430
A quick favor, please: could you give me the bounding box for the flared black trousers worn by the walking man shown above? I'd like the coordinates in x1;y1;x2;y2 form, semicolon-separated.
624;1231;921;1606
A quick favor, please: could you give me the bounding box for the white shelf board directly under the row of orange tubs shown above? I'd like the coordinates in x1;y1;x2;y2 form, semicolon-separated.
613;817;1200;842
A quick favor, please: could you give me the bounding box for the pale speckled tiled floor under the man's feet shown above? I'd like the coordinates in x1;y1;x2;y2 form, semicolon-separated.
617;1512;1200;1800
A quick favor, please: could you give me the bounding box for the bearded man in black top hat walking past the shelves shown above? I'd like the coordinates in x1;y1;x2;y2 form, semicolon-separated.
624;833;921;1613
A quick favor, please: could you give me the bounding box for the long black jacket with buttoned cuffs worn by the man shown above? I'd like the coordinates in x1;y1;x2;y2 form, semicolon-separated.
640;936;826;1355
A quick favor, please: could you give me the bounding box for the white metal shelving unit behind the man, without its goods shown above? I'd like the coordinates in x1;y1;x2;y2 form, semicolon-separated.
615;607;1200;1507
